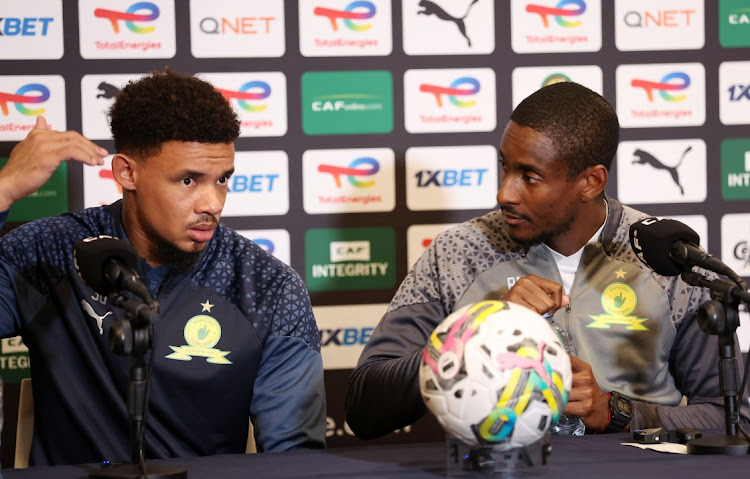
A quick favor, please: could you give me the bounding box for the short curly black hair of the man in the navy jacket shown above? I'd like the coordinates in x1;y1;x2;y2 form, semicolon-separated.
109;68;240;159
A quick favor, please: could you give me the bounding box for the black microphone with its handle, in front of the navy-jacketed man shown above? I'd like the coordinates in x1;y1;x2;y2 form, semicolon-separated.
73;235;156;309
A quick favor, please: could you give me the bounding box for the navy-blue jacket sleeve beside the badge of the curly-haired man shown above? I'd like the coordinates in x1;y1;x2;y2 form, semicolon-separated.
250;274;326;452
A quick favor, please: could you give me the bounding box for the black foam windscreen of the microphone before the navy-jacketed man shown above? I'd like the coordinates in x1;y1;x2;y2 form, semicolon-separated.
73;236;138;296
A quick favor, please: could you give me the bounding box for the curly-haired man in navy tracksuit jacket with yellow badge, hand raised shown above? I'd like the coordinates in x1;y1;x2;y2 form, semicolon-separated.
0;71;325;464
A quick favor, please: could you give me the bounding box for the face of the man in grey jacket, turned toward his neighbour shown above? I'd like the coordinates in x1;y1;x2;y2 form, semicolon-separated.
497;121;581;249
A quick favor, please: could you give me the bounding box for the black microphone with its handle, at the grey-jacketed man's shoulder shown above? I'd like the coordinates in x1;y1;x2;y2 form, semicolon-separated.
630;217;747;289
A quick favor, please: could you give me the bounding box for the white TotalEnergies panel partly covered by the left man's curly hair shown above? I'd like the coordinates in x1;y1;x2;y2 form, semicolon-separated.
200;72;287;137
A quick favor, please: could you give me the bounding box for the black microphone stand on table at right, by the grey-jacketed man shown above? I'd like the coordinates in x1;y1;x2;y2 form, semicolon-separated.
680;271;750;456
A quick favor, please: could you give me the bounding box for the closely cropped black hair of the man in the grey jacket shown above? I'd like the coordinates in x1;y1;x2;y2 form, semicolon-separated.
510;82;620;179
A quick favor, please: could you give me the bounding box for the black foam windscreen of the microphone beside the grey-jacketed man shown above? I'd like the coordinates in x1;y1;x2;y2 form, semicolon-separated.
630;217;700;276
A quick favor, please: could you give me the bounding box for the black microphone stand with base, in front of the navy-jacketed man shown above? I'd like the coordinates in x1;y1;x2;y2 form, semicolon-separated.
89;293;187;479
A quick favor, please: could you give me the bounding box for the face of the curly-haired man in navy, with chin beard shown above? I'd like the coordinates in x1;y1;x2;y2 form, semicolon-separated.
128;141;234;264
